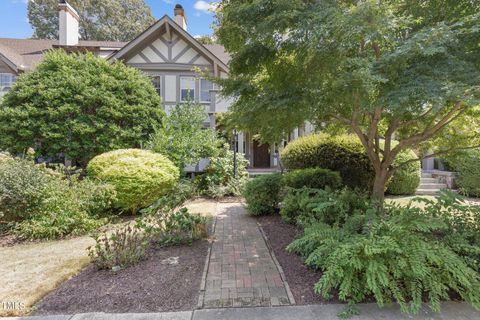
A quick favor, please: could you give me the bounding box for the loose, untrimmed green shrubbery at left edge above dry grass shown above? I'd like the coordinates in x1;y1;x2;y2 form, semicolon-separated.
0;155;116;239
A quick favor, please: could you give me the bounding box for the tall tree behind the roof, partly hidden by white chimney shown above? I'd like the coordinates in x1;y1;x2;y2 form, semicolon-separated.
28;0;155;41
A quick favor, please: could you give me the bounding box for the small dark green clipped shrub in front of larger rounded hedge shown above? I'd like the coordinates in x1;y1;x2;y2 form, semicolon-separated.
283;168;342;189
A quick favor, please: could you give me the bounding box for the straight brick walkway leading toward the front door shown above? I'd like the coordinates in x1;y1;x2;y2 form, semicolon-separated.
199;203;290;308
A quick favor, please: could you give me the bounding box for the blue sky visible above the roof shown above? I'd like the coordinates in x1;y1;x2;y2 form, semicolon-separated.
0;0;213;39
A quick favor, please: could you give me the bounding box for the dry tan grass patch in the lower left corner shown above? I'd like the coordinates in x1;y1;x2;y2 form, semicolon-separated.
0;237;94;316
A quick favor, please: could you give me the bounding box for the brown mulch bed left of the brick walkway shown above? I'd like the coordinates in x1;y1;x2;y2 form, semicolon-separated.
33;240;208;315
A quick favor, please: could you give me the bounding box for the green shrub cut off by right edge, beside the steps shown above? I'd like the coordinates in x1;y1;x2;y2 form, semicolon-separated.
451;150;480;197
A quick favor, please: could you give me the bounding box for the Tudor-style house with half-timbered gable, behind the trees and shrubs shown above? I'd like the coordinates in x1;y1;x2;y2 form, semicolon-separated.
0;0;313;170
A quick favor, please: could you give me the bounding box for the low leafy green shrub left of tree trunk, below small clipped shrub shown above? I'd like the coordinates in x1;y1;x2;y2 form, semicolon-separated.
280;188;369;226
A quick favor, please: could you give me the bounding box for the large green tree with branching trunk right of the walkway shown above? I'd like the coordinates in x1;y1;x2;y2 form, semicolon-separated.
216;0;480;199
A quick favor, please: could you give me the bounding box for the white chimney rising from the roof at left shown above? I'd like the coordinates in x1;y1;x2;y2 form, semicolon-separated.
58;0;80;46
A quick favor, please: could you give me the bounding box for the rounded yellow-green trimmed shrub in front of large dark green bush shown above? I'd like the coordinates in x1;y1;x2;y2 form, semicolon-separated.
87;149;180;213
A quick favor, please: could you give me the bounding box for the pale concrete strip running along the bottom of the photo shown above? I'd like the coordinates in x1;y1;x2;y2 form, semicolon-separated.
4;301;480;320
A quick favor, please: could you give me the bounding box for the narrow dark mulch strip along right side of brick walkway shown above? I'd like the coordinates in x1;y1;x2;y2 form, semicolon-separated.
258;215;339;305
